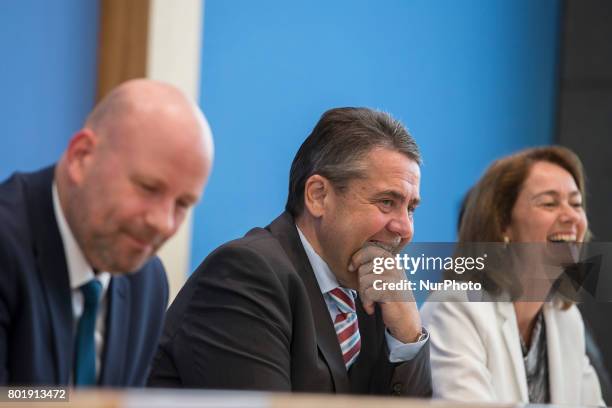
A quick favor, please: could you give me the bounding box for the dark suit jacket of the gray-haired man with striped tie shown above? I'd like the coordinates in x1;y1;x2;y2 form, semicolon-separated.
149;213;431;397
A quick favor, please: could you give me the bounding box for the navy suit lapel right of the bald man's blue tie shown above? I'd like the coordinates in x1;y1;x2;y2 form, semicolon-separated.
100;276;130;385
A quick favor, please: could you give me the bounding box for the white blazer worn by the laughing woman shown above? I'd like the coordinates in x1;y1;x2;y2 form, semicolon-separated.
421;295;605;405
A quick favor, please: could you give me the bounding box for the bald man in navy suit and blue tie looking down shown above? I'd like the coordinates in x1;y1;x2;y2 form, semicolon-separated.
0;79;213;387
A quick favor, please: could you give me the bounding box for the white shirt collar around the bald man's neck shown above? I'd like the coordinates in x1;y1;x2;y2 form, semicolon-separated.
51;182;110;294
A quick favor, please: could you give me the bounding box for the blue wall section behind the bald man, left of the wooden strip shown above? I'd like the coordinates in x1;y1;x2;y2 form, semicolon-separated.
0;0;99;179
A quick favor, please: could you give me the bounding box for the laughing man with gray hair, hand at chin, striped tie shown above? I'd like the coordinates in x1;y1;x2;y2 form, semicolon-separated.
149;108;431;397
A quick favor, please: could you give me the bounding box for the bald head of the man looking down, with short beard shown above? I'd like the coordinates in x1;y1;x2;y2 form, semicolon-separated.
56;79;213;272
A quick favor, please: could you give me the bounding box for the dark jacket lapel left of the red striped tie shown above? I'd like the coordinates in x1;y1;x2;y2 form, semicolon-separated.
268;212;350;392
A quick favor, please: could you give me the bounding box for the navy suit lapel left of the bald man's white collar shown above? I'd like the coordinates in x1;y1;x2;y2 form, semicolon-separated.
26;168;74;384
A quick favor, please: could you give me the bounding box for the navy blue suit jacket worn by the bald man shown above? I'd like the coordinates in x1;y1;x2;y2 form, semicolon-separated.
0;168;168;386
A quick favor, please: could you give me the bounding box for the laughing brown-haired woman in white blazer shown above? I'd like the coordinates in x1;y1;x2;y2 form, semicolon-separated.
421;146;603;405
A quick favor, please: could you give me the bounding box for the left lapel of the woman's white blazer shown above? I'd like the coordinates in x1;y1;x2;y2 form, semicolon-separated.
495;302;529;402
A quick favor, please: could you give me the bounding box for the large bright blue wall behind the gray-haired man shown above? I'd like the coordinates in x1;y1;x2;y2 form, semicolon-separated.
192;0;560;267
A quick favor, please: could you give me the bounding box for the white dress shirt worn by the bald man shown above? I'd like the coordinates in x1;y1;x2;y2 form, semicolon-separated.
52;182;111;382
